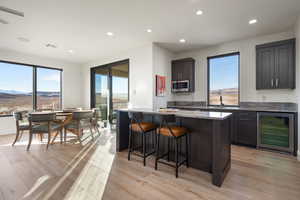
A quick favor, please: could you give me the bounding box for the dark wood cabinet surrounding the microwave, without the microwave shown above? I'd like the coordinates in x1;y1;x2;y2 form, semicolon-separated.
172;58;195;92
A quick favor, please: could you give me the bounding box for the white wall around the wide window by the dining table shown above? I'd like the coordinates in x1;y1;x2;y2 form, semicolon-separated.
0;50;82;135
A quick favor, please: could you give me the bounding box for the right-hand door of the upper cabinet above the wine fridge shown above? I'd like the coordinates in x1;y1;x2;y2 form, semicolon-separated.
274;42;295;89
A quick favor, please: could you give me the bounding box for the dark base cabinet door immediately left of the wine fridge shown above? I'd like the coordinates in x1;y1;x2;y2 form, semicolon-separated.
236;112;257;147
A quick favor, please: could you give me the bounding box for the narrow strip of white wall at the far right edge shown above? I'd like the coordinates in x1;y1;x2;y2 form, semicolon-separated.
295;15;300;156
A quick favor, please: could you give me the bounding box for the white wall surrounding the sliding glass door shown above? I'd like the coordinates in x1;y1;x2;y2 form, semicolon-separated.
82;43;154;108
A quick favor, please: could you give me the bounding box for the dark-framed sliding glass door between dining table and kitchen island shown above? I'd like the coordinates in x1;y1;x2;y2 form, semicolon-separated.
91;60;129;123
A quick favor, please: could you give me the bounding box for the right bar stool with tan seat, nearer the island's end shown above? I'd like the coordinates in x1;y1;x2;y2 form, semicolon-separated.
155;115;189;178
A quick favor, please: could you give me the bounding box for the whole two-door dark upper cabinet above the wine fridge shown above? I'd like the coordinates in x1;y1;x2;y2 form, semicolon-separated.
256;39;296;89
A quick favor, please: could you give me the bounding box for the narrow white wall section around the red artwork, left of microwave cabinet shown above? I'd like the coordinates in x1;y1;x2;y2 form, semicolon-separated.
153;44;174;109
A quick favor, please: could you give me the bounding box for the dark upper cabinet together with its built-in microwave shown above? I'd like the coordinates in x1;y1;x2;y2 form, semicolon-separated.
172;58;195;92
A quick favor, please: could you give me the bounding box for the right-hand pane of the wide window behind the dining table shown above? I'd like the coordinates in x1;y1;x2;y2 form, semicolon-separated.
36;68;61;110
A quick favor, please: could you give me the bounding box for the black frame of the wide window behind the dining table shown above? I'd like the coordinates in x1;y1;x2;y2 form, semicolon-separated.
0;60;63;118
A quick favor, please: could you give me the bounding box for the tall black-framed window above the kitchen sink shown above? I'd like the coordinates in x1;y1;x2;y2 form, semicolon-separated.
208;53;240;106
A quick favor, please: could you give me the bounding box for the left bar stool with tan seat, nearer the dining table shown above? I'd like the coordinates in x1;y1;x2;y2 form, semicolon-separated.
128;112;157;166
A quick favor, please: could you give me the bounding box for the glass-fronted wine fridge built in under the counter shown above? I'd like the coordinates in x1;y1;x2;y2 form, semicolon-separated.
257;112;295;153
